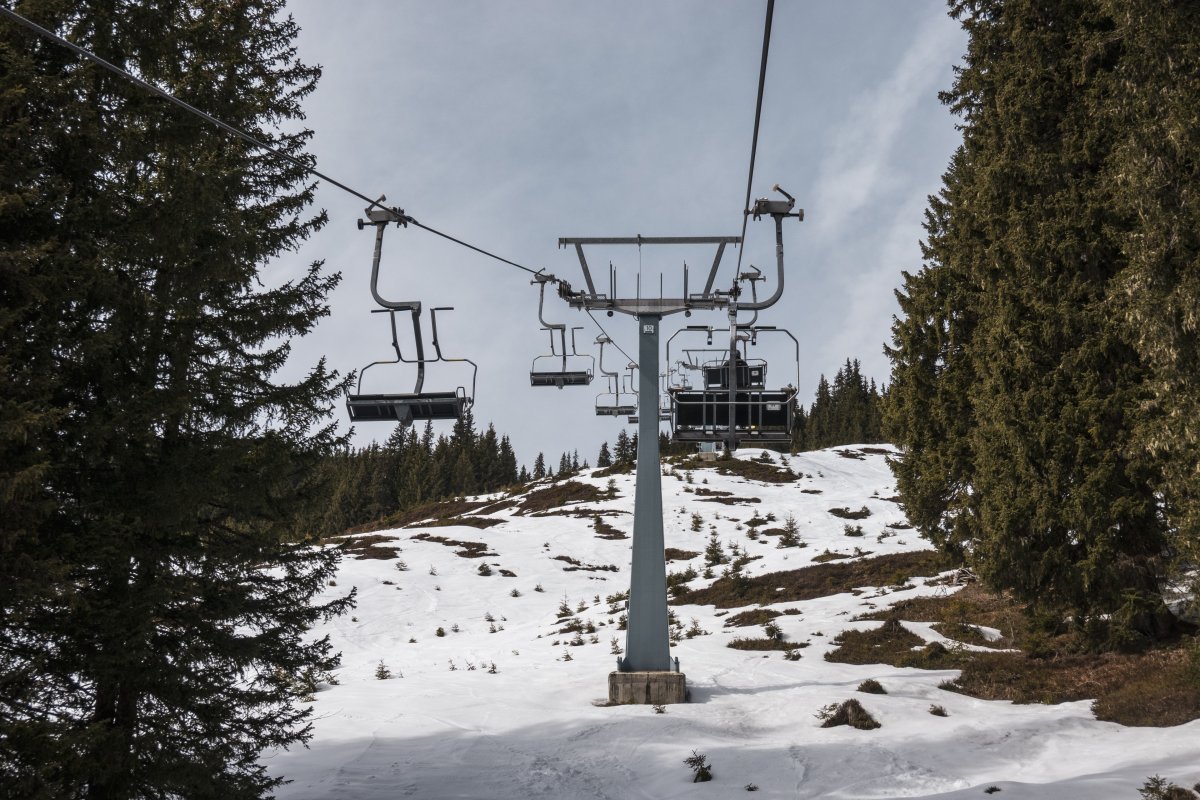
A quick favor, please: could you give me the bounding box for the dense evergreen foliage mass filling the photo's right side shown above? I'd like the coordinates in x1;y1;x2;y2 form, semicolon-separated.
886;0;1200;648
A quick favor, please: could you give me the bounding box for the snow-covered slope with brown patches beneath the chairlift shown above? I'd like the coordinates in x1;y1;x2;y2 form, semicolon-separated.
266;446;1200;800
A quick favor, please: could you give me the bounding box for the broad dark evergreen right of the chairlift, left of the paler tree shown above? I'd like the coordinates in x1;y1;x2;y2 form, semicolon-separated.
889;0;1169;644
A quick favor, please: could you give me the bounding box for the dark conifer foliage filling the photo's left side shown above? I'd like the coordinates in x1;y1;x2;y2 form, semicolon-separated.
0;0;349;799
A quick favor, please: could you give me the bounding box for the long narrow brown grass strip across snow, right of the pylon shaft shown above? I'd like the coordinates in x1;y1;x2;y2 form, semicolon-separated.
672;551;947;608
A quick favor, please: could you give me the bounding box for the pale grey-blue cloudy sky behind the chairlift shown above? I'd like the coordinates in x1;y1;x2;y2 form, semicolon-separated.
278;0;966;465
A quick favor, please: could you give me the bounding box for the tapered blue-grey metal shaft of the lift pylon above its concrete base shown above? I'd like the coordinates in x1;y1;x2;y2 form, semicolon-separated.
619;314;674;672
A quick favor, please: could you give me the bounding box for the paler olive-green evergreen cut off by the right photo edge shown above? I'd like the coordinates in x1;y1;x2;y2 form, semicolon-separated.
1100;0;1200;571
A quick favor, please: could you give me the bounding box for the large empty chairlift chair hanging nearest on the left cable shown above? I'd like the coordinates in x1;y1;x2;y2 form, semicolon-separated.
346;198;479;426
